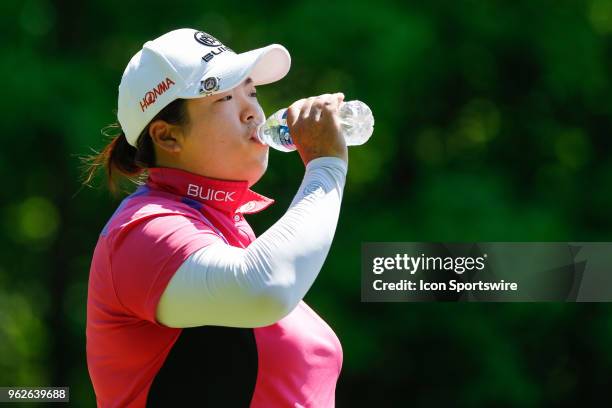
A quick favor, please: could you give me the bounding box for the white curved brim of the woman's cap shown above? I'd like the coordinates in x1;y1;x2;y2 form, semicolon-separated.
179;44;291;98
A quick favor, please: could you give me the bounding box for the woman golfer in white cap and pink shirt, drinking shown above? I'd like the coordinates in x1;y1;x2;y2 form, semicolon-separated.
87;29;348;408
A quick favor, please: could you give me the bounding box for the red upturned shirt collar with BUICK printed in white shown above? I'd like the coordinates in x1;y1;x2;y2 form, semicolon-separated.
147;167;274;214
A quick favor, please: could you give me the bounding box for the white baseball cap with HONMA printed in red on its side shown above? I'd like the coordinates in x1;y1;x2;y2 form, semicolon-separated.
117;28;291;146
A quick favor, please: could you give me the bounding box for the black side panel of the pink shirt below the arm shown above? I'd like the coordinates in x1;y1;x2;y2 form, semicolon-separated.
147;326;258;407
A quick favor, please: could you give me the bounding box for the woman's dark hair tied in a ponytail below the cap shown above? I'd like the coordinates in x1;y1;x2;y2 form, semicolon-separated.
81;99;189;195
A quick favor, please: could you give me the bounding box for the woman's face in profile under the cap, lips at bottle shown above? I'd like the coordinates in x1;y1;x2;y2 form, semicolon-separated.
175;78;268;186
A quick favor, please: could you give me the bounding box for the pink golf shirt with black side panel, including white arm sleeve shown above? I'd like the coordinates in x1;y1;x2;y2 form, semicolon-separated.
87;157;347;407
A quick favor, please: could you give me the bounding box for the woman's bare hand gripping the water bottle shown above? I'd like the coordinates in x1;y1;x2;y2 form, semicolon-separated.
287;93;348;165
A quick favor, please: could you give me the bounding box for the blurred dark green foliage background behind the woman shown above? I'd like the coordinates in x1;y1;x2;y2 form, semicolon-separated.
0;0;612;407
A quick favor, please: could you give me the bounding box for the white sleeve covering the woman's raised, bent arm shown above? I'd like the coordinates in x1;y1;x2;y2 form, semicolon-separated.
156;157;347;327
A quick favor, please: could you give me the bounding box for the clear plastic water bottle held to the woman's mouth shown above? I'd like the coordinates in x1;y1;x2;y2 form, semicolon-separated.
257;101;374;152
